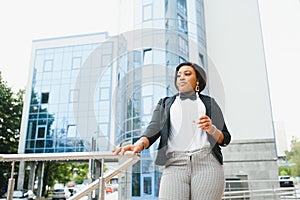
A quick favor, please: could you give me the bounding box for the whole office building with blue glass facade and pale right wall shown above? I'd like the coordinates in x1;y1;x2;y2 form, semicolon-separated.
19;0;277;199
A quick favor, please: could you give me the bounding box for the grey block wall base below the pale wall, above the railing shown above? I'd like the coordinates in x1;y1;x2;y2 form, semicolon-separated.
223;139;277;179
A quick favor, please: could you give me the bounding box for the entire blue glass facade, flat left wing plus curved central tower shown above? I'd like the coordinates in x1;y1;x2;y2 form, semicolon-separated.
25;0;206;199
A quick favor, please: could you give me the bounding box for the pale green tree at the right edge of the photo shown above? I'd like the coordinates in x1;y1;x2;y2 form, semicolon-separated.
285;137;300;177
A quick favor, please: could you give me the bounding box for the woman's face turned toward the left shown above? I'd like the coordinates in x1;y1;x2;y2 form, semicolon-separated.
176;65;197;92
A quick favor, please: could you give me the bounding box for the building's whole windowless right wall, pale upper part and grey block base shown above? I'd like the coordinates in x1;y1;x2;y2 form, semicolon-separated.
204;0;278;192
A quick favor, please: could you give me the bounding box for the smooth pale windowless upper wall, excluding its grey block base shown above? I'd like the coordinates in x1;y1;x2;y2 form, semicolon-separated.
204;0;274;140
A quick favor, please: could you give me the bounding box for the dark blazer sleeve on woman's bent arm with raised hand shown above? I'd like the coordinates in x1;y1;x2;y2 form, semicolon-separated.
211;98;231;146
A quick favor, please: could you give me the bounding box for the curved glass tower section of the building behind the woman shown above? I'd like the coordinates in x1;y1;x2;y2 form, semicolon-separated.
115;0;206;199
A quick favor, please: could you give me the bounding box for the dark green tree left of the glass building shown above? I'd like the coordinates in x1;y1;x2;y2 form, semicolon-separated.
0;72;24;194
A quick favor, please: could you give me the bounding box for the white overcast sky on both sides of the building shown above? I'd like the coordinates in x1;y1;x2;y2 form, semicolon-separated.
0;0;300;147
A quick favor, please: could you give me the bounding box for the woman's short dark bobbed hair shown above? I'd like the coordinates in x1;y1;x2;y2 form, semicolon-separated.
174;62;206;93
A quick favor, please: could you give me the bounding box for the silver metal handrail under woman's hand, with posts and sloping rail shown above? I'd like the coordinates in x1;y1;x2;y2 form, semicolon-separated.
0;151;140;200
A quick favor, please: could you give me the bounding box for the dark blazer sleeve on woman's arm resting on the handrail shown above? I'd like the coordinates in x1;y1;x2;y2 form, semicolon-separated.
141;99;165;147
